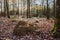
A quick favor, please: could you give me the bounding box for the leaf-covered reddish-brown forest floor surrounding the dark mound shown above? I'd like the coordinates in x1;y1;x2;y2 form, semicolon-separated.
0;17;57;40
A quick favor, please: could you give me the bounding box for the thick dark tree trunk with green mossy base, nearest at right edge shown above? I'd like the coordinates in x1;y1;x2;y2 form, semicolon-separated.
53;0;60;37
